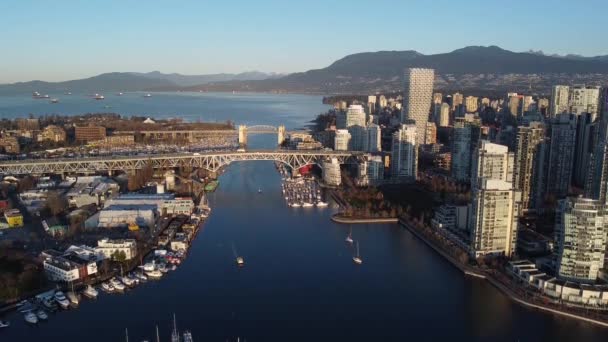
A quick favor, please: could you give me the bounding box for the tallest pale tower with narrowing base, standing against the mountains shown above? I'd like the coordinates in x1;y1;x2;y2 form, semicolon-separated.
401;68;435;146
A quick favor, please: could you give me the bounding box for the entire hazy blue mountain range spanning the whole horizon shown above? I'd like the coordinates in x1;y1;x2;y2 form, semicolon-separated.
0;46;608;94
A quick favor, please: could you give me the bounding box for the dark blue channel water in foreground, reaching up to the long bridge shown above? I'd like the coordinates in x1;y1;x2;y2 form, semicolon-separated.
0;95;608;341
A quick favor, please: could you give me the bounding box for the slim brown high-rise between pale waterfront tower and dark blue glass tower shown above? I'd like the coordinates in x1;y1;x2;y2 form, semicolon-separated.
513;122;545;211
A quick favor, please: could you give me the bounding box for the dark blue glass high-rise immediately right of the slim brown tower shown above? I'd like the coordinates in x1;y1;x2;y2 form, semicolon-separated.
546;113;576;198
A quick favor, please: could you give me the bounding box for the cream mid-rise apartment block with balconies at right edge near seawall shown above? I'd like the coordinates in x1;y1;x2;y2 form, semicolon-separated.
555;197;608;283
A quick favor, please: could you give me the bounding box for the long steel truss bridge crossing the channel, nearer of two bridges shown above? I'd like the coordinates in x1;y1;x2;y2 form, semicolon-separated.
0;150;365;176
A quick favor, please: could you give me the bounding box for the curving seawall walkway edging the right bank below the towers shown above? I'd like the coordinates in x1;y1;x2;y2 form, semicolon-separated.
398;219;608;328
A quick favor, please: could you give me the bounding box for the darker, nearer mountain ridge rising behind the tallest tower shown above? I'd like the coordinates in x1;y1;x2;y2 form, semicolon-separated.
183;46;608;94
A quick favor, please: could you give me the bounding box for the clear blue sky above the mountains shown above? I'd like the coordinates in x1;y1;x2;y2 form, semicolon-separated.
0;0;608;83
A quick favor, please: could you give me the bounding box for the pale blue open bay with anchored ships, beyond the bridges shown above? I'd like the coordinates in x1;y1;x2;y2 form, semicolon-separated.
0;93;329;129
